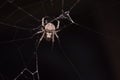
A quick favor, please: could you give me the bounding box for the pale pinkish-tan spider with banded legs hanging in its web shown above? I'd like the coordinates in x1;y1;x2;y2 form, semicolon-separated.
34;17;60;47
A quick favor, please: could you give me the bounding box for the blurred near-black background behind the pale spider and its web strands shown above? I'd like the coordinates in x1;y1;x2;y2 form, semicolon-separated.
0;0;120;80
